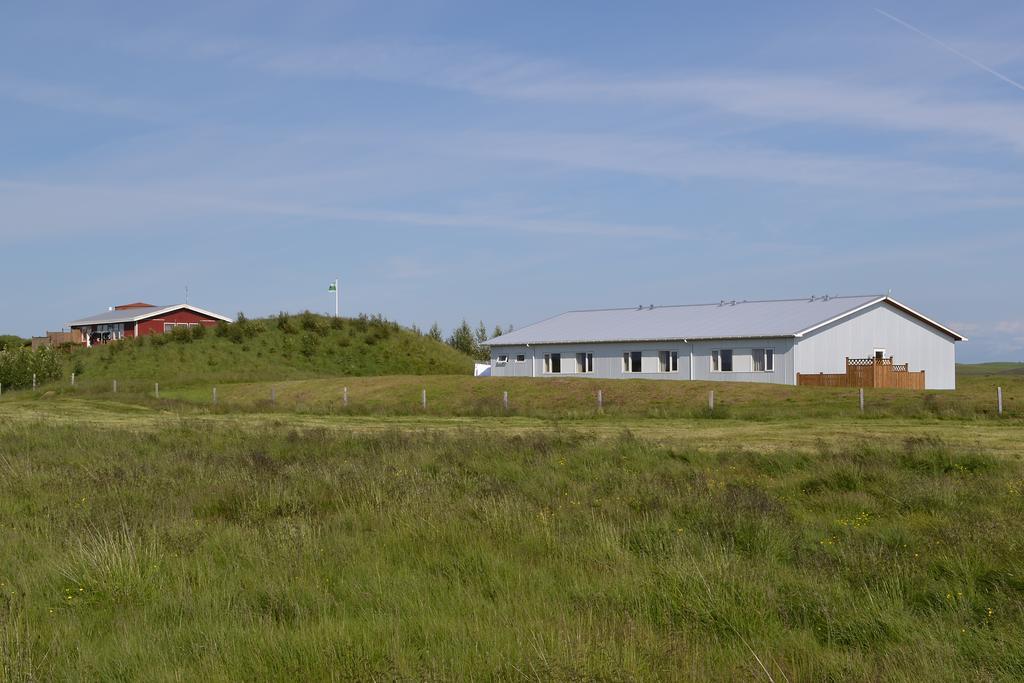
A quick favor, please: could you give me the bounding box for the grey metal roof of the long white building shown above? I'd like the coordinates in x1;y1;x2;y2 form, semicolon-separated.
487;294;963;346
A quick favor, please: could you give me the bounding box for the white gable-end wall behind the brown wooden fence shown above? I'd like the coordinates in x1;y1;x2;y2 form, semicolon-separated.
796;302;956;389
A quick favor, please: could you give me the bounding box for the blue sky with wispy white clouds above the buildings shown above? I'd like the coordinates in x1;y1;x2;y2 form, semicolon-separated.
0;0;1024;361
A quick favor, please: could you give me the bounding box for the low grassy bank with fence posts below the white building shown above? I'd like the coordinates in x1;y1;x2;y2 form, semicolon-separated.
22;368;1024;421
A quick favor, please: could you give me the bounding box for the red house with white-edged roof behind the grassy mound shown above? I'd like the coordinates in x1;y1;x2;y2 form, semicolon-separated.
68;301;231;346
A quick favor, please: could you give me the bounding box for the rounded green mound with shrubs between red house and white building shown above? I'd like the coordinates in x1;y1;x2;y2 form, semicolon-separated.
67;313;473;385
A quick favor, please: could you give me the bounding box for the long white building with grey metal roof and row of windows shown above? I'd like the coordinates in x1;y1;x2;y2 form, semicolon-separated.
488;295;967;389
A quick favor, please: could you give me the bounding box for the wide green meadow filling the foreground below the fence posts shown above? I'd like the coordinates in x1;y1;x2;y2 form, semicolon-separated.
0;409;1024;681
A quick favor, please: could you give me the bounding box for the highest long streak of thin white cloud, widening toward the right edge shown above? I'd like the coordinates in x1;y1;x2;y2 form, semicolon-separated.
125;36;1024;152
